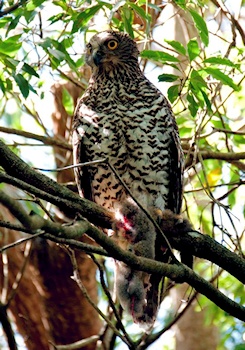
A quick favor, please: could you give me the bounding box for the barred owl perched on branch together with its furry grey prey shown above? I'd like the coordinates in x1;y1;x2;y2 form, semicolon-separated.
73;31;183;324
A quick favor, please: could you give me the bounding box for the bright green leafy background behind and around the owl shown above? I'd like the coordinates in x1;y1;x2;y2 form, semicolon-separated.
0;0;245;349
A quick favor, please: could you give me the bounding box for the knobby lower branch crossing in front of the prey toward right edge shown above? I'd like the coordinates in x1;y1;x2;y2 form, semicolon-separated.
0;209;245;321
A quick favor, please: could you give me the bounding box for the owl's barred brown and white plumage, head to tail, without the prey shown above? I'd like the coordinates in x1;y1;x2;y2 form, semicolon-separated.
73;31;183;322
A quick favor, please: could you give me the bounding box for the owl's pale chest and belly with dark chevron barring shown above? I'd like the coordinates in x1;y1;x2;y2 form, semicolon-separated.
75;81;172;209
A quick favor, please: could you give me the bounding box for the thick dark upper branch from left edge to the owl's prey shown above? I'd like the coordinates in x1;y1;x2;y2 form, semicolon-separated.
0;140;112;227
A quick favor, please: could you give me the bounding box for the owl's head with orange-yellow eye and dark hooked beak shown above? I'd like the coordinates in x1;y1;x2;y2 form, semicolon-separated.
86;30;139;69
